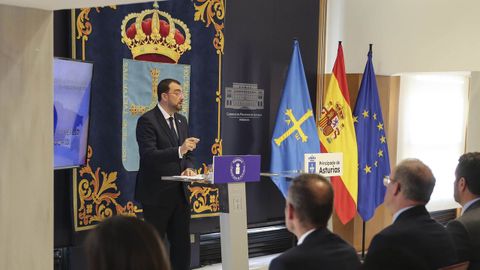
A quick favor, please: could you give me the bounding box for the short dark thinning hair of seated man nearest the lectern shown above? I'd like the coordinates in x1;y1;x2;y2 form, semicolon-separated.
288;174;333;228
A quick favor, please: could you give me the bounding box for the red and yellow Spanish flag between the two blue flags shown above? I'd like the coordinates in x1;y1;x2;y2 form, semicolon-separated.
318;42;358;224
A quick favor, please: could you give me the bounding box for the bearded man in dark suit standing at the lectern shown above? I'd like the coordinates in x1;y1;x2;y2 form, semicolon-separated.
135;79;199;270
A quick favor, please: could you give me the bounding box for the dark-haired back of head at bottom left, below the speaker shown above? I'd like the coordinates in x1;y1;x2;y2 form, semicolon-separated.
85;216;170;270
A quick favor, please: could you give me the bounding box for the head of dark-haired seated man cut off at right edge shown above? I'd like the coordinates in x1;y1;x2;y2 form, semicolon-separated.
454;152;480;206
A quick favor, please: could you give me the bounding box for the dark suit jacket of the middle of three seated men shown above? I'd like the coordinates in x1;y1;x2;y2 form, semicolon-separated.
363;206;457;269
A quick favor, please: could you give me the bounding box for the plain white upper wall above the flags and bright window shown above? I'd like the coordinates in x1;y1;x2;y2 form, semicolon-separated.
325;0;480;75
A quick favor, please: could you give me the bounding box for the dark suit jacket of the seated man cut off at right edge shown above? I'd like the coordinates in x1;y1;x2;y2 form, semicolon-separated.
447;201;480;270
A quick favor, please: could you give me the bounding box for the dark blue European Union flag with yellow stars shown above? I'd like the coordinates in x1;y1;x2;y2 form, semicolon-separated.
353;49;390;221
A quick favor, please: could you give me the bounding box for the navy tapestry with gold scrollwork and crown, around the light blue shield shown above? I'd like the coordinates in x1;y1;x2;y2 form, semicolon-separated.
72;0;225;231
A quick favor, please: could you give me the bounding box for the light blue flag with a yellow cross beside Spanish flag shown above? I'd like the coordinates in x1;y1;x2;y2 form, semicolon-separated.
270;40;320;196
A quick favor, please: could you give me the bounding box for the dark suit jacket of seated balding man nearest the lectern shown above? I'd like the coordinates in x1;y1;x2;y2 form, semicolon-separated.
269;228;360;270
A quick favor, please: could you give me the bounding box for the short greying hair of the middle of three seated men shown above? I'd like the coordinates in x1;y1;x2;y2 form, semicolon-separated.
393;159;435;204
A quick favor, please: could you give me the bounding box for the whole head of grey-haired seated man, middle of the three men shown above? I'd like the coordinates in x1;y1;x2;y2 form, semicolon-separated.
385;159;435;214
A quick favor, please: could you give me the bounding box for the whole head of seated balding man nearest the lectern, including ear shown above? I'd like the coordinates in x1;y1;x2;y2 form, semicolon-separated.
285;174;333;238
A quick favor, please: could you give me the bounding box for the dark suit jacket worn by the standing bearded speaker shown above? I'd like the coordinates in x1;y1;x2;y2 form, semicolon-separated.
135;106;193;205
